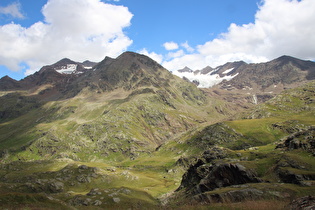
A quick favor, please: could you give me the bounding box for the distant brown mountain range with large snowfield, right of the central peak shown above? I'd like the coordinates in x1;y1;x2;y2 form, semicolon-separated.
173;56;315;92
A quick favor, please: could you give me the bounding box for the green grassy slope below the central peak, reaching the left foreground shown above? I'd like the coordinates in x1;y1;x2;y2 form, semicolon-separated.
0;76;231;209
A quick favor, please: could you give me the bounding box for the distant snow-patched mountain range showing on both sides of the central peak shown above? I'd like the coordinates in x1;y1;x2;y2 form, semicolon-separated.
0;53;315;93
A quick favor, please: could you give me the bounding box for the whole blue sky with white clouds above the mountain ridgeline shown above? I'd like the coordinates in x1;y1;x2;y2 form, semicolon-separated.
0;0;315;80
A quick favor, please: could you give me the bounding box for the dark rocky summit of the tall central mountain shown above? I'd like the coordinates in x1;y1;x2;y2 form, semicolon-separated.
91;52;172;89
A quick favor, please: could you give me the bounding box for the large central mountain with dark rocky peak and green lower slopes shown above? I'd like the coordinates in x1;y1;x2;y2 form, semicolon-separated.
0;52;230;161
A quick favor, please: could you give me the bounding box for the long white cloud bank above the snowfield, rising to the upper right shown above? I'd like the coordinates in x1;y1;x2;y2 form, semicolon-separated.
163;0;315;70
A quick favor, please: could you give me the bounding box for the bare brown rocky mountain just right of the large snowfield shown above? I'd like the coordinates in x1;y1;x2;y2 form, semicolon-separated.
220;56;315;93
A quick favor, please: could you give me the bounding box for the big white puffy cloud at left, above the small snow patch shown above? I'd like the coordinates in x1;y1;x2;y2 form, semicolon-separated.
0;0;133;75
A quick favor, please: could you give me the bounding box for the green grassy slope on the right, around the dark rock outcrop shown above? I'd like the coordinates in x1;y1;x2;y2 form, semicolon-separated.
165;82;315;209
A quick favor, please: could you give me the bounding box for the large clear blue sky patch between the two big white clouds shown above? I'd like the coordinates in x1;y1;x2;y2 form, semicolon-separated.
118;0;257;52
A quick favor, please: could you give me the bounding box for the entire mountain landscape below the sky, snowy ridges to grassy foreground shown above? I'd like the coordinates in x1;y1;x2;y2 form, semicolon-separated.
0;52;315;209
